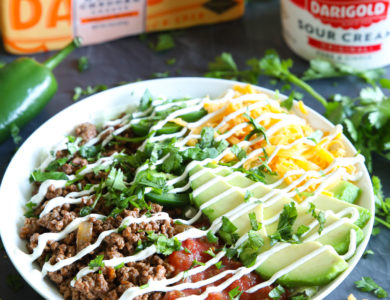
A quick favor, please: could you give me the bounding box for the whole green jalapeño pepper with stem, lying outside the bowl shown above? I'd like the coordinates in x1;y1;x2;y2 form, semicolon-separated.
0;38;80;143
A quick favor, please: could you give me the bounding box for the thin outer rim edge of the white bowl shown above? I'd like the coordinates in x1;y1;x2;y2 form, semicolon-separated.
0;77;375;300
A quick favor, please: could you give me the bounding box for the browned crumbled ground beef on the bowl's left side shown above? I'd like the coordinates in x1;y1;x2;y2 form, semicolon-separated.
20;123;181;300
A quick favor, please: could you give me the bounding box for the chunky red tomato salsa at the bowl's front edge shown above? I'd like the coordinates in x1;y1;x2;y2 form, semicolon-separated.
164;239;286;300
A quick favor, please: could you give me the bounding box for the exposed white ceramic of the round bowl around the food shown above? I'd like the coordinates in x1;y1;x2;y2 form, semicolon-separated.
0;78;374;300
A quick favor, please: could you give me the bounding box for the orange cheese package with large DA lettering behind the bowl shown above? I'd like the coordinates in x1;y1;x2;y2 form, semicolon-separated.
0;0;245;54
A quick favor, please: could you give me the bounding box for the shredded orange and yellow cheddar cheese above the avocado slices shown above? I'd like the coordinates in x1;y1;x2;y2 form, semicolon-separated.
188;85;355;201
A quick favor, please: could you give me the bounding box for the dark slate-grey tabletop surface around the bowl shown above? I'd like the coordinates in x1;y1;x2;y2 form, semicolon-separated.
0;0;390;300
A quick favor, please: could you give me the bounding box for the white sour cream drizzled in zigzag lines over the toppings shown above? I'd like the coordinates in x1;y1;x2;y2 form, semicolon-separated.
25;91;362;299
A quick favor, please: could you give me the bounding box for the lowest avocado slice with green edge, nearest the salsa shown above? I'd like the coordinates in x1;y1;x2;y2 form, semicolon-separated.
256;242;348;287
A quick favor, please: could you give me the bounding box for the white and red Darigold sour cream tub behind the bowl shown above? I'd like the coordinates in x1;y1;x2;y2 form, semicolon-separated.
281;0;390;69
